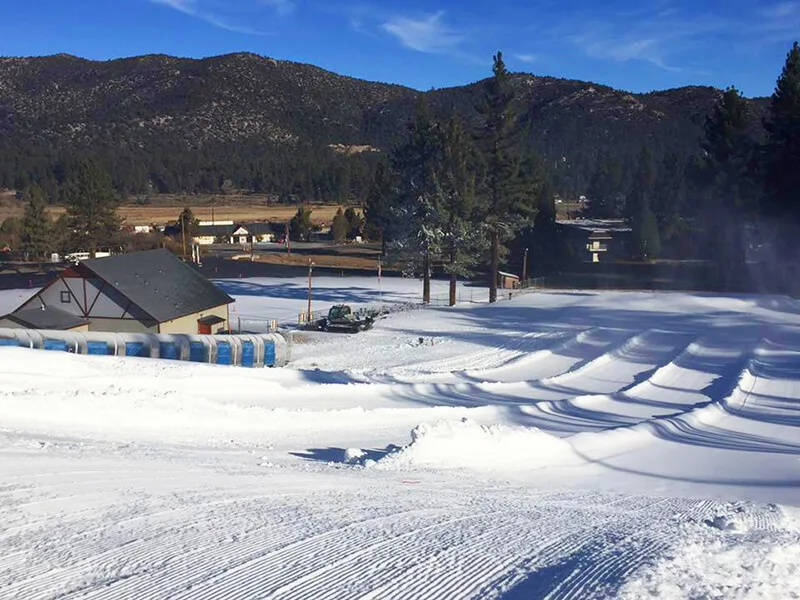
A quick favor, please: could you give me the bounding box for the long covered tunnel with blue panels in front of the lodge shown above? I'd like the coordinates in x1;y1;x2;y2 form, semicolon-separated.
0;329;291;367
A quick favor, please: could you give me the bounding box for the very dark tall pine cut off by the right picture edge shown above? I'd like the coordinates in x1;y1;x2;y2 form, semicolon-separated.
764;42;800;223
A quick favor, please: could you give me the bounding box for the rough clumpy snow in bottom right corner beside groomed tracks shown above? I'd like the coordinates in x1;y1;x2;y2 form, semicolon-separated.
619;515;800;600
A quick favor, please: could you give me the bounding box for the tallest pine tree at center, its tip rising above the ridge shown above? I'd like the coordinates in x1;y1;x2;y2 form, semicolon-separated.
478;52;534;302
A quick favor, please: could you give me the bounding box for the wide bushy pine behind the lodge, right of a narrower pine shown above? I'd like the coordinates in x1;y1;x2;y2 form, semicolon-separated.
61;161;121;257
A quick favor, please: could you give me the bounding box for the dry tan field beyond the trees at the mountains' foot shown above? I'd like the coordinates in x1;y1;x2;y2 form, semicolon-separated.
0;192;354;225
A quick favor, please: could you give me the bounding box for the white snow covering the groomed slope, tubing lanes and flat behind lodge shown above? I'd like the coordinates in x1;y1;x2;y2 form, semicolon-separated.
0;278;800;600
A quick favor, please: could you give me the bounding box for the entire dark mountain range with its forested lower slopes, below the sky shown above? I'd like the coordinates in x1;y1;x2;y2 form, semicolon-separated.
0;54;763;202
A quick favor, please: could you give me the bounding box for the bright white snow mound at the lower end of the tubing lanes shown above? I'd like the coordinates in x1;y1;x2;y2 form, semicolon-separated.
376;418;581;472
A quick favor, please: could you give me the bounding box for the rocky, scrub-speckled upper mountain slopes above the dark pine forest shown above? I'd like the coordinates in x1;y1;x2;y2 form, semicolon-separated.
0;54;760;195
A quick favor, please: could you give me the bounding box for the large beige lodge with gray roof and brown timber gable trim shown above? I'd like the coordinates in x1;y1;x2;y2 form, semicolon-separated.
0;250;233;334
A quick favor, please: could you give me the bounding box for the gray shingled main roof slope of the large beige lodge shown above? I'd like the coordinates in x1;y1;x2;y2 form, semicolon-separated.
78;250;233;323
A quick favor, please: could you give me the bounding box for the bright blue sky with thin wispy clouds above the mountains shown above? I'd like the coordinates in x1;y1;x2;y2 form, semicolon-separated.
0;0;800;96
